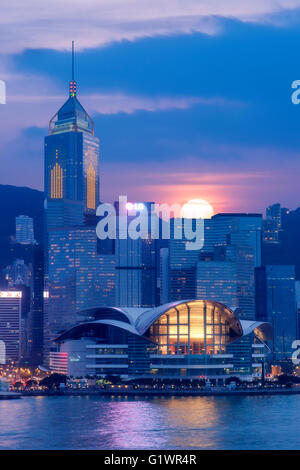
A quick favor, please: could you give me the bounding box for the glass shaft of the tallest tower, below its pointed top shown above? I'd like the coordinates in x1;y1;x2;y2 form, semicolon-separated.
45;131;99;229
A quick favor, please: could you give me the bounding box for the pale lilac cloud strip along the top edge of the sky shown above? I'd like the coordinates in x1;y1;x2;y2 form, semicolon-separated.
0;0;300;54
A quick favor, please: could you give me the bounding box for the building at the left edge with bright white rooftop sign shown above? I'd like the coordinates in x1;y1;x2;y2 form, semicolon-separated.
0;291;22;364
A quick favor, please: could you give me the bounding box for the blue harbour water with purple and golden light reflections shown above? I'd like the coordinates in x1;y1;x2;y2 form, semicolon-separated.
0;395;300;449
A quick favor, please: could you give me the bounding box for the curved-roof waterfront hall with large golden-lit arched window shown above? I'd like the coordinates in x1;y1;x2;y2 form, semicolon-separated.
51;300;272;382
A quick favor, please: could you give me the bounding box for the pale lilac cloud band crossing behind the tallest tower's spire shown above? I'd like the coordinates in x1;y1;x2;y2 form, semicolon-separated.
0;55;244;146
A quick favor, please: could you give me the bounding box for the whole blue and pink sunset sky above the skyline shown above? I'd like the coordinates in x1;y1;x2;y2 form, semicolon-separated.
0;0;300;212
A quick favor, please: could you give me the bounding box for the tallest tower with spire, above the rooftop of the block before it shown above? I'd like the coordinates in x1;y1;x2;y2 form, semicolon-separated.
45;44;99;230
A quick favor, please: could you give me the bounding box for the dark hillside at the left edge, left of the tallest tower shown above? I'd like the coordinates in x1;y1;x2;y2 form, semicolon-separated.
0;185;44;277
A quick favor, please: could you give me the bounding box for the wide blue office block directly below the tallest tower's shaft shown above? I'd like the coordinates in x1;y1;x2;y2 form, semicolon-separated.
44;227;116;357
